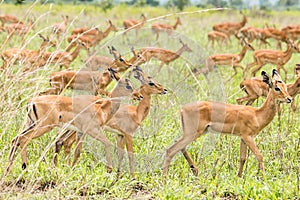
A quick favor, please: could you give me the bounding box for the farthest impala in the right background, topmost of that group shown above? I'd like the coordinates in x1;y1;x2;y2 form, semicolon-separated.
213;12;247;35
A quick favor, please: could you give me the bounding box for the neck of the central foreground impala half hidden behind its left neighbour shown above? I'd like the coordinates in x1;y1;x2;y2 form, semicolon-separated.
136;88;151;123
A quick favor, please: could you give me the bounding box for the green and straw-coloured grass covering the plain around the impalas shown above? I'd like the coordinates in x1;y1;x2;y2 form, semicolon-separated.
0;4;300;199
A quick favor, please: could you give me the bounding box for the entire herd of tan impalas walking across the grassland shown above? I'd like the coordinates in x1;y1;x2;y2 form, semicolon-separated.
0;11;300;180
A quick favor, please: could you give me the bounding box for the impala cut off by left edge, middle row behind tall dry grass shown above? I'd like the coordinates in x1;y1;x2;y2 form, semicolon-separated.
1;34;56;70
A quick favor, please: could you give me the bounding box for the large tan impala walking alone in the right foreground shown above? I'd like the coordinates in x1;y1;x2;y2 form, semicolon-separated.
163;69;292;177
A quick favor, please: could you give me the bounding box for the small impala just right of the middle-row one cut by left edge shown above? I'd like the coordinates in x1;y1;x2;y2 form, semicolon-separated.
38;42;89;69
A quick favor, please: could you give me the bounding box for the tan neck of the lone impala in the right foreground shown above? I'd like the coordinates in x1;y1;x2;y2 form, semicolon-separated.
256;89;276;129
